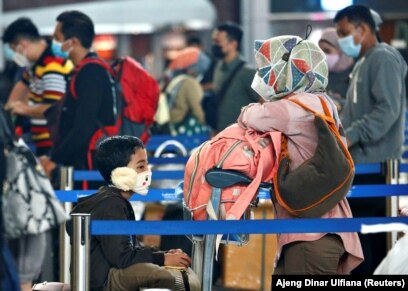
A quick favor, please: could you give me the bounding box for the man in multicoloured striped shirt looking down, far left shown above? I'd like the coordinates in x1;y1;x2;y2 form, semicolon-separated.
3;17;73;156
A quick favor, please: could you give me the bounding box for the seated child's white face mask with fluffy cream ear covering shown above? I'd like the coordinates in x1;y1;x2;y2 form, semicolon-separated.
111;167;152;195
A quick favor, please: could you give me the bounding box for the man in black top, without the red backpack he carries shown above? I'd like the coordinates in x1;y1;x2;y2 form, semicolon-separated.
41;11;115;174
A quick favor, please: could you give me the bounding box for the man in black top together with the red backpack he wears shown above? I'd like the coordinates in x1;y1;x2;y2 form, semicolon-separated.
42;11;160;176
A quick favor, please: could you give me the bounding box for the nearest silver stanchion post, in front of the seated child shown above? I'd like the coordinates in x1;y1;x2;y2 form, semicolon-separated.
71;213;91;291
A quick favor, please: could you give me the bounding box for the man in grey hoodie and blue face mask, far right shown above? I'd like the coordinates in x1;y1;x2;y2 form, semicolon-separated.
334;5;407;274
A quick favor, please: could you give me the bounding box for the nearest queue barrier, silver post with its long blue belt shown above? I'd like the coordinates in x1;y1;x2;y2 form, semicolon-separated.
72;214;408;291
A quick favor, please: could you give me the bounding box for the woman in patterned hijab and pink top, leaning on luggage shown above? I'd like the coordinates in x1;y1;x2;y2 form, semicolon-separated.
238;36;363;275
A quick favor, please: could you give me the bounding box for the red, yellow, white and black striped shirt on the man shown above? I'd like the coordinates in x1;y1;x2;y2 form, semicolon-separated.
22;45;73;150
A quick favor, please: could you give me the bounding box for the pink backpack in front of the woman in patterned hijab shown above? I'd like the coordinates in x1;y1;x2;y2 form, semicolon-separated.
183;124;281;220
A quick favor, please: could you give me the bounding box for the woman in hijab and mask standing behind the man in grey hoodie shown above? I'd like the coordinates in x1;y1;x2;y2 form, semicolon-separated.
319;27;354;111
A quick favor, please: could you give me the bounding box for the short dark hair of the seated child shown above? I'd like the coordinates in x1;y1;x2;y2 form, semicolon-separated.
95;135;145;183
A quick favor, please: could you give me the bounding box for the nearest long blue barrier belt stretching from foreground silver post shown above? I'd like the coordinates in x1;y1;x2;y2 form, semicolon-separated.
91;216;408;235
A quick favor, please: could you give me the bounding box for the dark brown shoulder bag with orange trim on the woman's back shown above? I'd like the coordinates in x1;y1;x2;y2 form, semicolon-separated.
271;96;354;217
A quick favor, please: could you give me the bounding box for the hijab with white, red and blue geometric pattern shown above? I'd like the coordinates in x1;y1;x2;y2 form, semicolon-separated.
255;35;328;101
